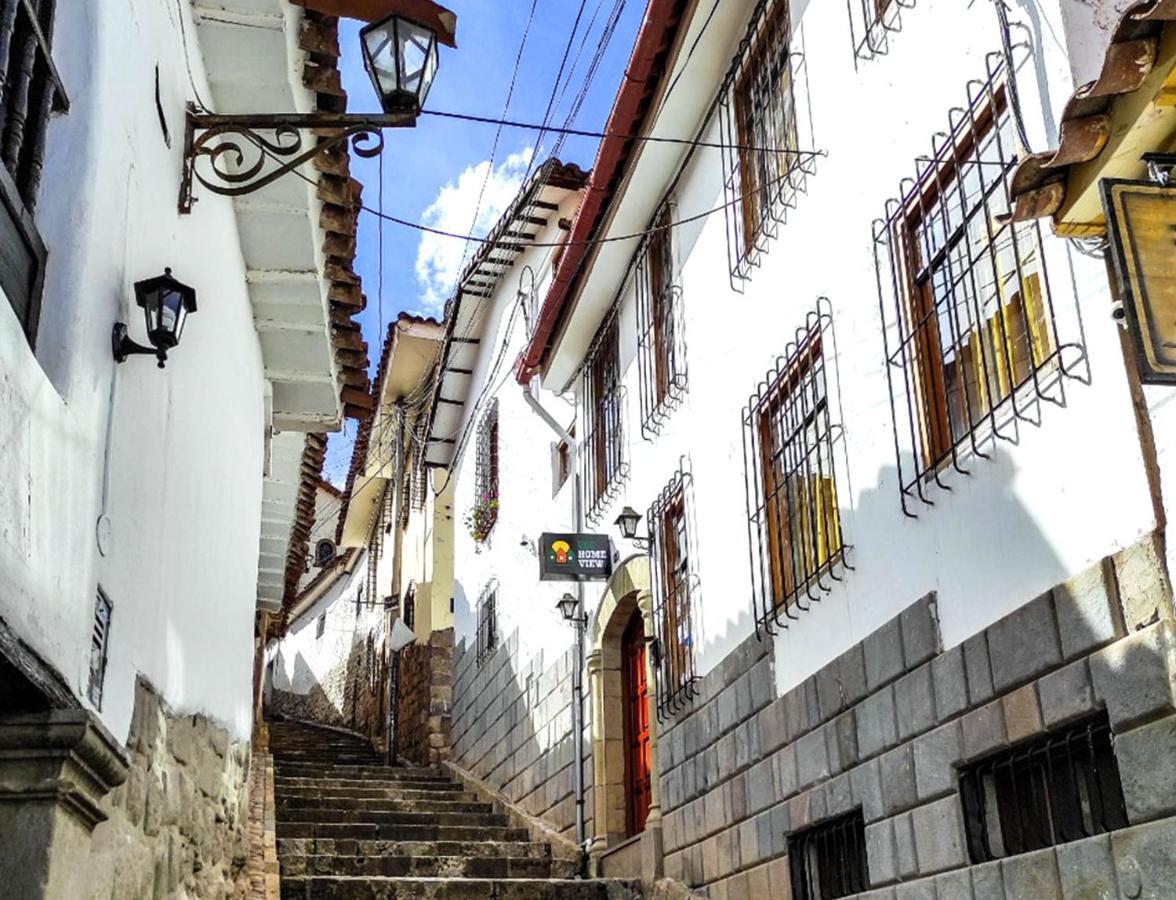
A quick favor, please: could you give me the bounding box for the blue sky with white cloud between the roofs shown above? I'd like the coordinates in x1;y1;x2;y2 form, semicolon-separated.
323;0;646;485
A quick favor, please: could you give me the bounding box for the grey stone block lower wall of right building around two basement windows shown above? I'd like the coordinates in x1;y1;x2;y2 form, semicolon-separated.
659;539;1176;900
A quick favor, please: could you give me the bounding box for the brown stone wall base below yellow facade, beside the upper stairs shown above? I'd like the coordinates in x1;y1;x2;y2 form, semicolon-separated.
396;628;453;766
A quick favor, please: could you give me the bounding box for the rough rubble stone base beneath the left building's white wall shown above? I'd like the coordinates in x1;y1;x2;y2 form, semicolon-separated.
84;679;249;900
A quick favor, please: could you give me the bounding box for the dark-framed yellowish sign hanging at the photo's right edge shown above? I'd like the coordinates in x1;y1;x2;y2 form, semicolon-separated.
1102;179;1176;385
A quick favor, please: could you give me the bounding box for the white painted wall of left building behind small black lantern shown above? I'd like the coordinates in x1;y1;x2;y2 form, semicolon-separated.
0;0;277;739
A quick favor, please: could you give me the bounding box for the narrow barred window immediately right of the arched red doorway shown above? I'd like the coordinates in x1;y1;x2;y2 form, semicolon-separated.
646;459;700;721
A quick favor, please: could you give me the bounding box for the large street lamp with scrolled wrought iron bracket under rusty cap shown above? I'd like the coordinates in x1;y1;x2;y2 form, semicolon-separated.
180;0;457;213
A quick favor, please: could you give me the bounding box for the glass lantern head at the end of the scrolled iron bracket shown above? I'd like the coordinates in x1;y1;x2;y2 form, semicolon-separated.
360;15;437;115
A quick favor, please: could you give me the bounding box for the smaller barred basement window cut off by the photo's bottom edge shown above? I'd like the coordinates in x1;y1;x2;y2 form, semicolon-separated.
788;809;869;900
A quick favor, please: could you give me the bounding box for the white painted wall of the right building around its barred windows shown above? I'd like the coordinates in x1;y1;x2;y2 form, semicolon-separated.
538;0;1157;691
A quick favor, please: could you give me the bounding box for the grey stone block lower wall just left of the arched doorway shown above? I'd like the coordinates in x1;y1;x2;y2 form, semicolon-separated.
452;632;593;838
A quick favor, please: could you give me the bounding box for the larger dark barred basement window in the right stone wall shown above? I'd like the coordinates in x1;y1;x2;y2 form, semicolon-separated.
960;713;1128;862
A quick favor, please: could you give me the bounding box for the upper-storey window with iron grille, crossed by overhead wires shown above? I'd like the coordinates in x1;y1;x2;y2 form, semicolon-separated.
719;0;816;289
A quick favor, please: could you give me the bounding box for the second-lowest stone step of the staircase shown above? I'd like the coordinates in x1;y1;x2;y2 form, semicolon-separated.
279;855;566;879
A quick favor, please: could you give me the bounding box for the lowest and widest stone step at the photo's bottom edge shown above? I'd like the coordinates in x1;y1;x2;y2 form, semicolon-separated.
282;875;641;900
